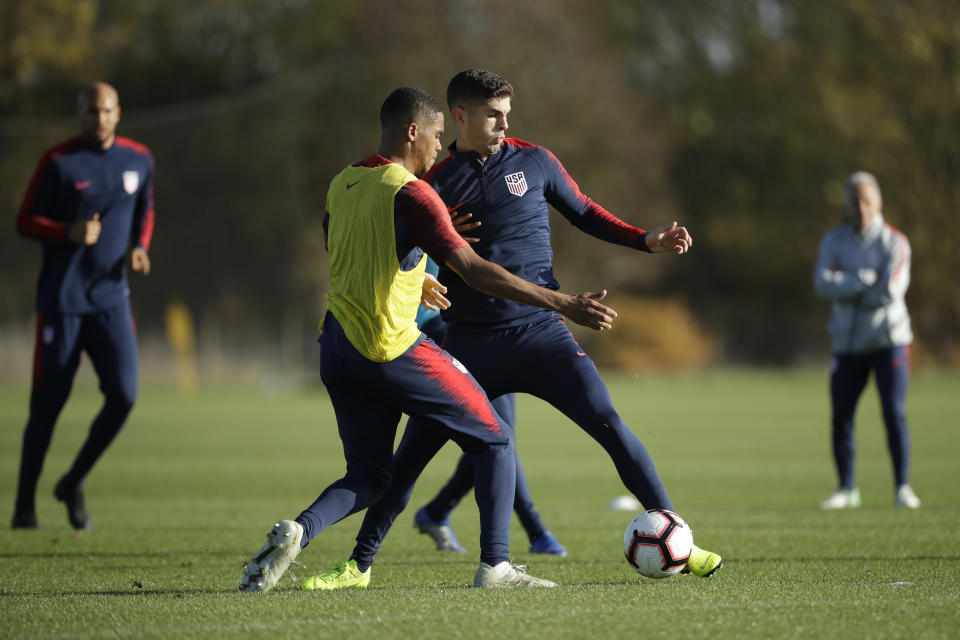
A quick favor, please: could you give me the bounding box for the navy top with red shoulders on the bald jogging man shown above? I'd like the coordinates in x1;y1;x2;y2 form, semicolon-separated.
17;136;154;313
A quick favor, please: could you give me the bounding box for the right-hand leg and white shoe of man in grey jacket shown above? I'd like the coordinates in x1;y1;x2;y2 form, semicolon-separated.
874;346;920;509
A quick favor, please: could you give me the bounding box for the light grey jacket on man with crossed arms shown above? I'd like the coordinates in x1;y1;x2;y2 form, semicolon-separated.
813;213;913;353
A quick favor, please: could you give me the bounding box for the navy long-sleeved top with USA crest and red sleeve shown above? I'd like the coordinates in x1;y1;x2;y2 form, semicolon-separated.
423;138;648;333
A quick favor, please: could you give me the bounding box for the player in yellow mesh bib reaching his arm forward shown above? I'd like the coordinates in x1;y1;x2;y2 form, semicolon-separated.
240;87;616;591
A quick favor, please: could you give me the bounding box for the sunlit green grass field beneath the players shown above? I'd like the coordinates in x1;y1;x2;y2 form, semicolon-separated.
0;371;960;638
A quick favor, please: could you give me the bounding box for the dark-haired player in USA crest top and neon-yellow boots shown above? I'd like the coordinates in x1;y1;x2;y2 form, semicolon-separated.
304;69;722;589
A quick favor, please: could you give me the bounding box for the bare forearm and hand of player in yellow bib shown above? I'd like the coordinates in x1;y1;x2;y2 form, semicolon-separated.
446;247;617;331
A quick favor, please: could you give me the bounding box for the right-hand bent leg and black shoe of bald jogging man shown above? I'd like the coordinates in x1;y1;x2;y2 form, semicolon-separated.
54;304;138;529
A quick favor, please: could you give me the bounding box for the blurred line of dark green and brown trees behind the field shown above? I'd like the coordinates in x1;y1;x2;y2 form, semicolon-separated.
0;0;960;366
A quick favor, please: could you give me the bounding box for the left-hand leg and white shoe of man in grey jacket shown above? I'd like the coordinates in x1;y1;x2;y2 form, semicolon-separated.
820;354;870;509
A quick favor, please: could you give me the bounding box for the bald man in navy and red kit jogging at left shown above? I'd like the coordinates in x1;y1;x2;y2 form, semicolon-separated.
12;82;154;529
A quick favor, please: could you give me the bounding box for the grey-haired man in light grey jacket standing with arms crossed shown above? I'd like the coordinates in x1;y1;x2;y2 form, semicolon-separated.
813;171;920;509
